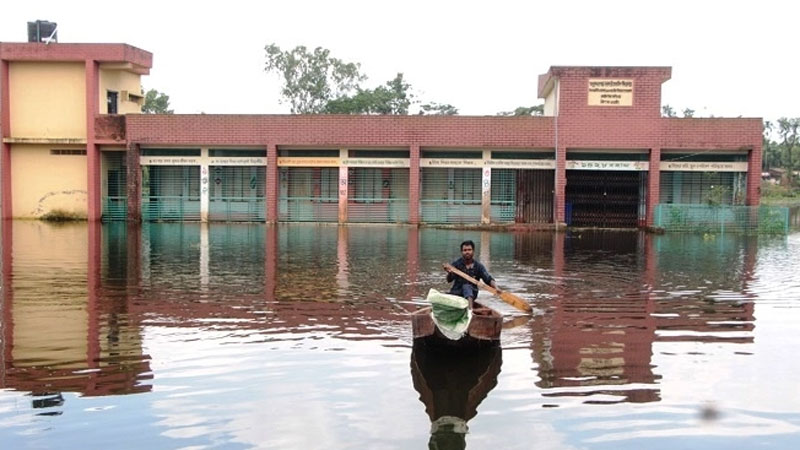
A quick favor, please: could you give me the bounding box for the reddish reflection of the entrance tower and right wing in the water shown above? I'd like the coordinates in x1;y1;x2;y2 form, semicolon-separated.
532;233;755;403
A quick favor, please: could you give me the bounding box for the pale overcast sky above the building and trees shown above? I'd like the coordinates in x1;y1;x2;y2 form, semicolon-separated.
0;0;800;120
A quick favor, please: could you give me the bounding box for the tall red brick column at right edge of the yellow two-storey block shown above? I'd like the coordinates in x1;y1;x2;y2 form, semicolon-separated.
85;59;102;222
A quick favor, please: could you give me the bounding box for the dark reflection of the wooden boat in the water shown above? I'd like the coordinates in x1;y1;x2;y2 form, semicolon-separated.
411;343;503;450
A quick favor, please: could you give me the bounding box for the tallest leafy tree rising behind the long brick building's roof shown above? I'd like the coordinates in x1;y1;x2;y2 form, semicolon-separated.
264;44;365;114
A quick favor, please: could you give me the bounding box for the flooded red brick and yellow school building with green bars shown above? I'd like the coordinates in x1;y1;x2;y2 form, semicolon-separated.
0;34;762;227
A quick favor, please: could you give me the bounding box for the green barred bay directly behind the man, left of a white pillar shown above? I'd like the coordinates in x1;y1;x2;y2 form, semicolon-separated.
420;168;481;223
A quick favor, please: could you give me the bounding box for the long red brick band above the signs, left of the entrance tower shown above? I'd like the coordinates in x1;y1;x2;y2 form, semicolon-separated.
126;114;553;148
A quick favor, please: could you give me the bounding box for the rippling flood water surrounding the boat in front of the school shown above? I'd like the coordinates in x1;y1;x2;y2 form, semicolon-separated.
0;221;800;449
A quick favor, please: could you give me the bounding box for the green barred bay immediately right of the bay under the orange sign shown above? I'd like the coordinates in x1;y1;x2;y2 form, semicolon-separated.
347;167;408;223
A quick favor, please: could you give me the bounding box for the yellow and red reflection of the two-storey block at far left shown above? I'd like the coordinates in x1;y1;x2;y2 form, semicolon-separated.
0;222;151;398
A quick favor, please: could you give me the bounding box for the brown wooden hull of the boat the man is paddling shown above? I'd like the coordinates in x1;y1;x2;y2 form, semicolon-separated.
411;302;503;347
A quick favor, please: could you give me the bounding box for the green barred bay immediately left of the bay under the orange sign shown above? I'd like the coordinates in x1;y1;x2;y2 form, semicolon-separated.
208;166;267;222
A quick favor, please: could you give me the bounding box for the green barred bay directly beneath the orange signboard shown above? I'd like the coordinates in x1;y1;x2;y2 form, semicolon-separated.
278;167;339;222
